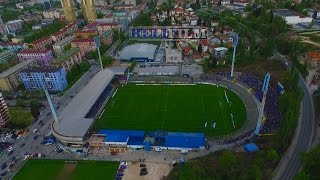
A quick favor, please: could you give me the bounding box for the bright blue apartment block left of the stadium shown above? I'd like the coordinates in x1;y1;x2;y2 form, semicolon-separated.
20;67;68;92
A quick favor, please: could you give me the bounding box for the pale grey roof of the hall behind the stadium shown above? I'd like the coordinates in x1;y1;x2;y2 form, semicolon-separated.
119;43;158;60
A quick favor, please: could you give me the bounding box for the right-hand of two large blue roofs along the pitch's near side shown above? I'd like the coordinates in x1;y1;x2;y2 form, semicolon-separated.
164;132;205;148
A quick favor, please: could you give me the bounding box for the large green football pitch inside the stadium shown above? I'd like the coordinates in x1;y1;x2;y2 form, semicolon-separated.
93;84;246;136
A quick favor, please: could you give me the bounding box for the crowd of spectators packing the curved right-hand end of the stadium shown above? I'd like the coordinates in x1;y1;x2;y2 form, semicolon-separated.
200;72;281;134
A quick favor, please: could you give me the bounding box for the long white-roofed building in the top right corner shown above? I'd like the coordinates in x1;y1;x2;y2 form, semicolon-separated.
274;9;312;25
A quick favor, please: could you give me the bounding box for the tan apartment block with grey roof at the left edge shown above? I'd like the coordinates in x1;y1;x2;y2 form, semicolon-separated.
0;60;36;91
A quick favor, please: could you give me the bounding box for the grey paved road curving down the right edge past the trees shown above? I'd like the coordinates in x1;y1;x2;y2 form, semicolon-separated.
274;53;315;180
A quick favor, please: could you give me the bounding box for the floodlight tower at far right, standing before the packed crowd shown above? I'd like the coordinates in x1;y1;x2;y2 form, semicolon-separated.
254;73;270;136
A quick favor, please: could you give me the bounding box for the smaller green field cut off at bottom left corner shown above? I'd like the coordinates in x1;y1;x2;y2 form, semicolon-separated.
13;159;119;180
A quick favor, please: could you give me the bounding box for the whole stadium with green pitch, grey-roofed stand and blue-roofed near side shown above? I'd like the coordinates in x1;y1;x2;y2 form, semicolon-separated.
51;65;258;152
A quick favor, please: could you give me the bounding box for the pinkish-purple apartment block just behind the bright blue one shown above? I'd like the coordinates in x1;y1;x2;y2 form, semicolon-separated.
17;49;53;66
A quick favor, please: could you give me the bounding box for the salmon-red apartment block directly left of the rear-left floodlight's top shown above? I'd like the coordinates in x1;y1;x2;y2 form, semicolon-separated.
71;38;97;56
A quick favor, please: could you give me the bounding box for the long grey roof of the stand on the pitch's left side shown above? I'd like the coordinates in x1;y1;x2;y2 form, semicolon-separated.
54;69;114;137
